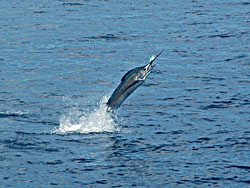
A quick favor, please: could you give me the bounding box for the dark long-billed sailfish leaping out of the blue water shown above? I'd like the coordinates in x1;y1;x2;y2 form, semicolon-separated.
107;49;164;111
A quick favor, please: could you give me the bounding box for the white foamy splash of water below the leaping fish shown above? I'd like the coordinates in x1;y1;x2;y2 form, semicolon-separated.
52;96;121;134
